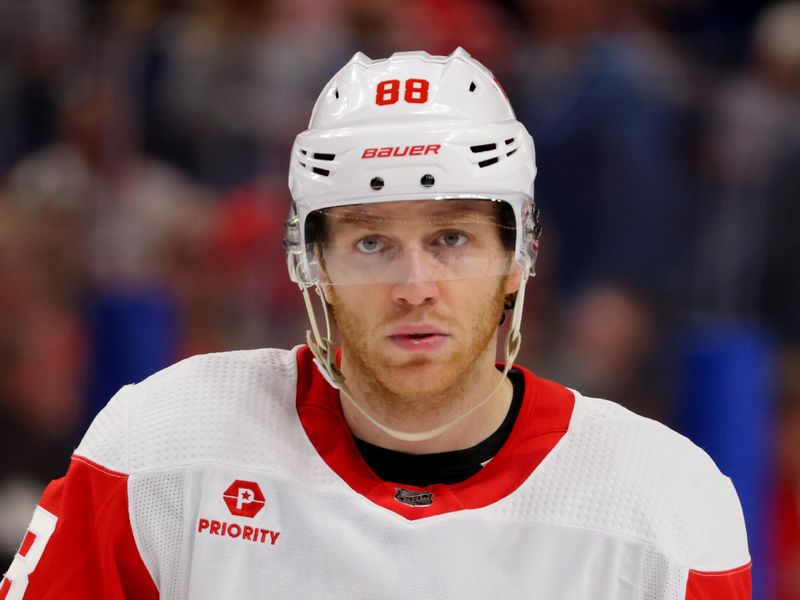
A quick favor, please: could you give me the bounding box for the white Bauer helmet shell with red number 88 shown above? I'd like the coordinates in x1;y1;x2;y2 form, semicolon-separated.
285;48;539;287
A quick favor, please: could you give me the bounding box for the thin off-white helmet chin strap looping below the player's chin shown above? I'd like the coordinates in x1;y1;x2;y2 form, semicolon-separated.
302;269;528;442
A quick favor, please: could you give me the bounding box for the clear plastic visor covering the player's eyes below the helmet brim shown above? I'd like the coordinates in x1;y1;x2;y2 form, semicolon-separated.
306;200;521;285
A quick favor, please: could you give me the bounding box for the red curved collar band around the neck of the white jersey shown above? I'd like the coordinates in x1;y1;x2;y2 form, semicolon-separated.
297;347;575;520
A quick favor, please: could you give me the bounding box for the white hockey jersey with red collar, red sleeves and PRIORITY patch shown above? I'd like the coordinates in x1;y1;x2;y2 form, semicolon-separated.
0;348;750;600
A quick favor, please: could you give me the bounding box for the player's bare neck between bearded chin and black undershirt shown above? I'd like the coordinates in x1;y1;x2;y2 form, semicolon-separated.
342;345;513;454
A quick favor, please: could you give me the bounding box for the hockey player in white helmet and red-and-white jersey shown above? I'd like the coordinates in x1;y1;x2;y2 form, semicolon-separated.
0;49;750;600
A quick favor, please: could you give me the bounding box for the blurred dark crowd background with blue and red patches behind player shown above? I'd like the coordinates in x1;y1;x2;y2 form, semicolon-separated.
0;0;800;600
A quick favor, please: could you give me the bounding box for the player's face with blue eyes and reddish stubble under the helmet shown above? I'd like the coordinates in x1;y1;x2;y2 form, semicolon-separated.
323;200;519;408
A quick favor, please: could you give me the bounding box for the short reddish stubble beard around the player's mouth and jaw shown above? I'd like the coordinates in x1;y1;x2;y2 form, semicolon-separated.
328;282;505;420
